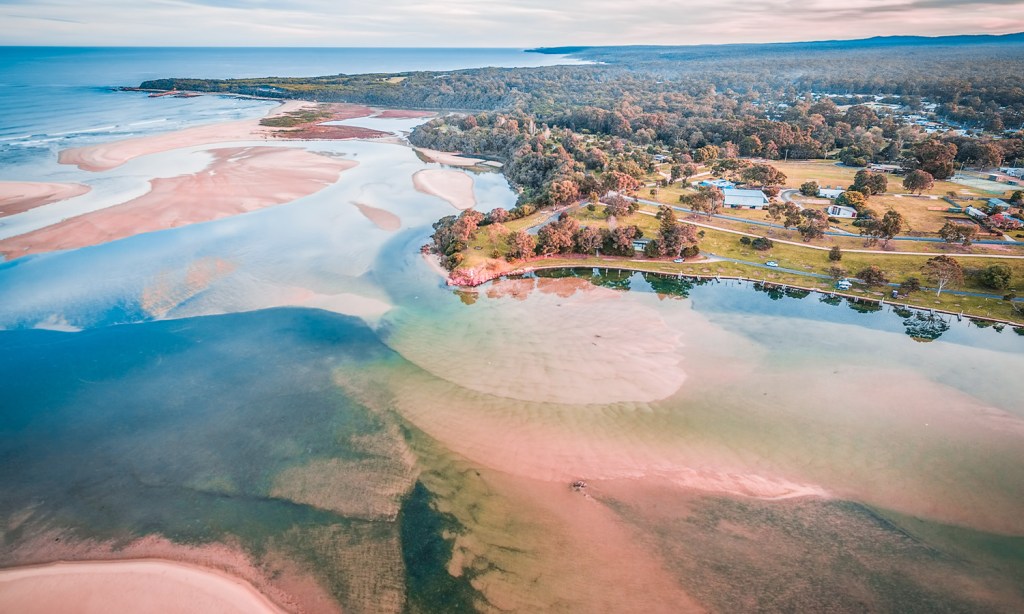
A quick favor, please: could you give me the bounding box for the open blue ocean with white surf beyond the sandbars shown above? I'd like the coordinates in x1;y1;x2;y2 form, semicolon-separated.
0;47;577;173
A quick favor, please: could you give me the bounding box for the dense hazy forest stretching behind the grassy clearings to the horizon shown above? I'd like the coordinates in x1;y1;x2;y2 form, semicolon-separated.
141;35;1024;210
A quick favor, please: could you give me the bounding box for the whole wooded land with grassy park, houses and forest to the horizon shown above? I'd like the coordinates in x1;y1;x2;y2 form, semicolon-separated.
140;35;1024;321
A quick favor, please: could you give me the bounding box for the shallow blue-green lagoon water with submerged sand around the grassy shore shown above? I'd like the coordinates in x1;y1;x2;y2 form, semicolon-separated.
0;46;1024;612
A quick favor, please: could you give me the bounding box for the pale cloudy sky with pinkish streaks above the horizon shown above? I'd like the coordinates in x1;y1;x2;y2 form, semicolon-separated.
6;0;1024;47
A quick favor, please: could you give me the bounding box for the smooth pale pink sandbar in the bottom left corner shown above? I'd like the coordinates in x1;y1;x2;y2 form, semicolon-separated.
0;560;284;614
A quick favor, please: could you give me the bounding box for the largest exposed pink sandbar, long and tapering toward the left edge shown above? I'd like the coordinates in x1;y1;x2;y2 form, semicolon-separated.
0;146;357;259
